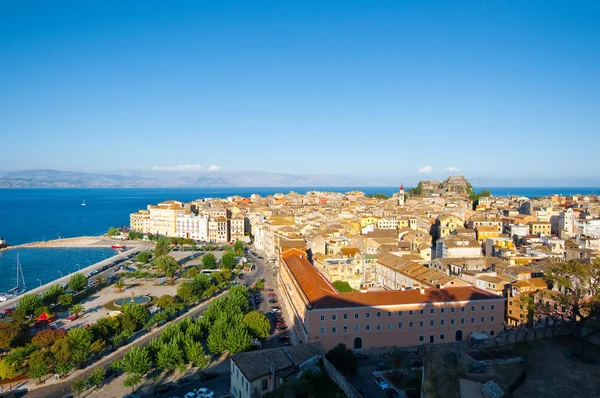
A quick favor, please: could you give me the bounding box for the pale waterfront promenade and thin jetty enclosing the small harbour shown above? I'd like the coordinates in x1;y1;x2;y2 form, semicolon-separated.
0;238;153;312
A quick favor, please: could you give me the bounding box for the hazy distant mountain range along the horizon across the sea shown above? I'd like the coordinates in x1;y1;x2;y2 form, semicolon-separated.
0;170;391;188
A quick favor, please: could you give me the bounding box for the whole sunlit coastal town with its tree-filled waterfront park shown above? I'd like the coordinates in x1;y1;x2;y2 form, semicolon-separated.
0;176;600;398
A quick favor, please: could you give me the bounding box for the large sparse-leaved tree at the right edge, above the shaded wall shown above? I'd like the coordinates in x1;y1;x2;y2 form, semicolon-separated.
529;258;600;356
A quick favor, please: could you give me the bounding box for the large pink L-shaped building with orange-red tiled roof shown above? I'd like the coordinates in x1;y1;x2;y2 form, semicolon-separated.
278;248;505;350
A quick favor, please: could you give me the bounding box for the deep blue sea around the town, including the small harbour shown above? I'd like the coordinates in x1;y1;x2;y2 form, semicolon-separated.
0;187;600;291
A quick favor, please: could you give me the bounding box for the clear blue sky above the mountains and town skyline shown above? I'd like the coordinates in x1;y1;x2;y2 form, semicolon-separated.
0;0;600;185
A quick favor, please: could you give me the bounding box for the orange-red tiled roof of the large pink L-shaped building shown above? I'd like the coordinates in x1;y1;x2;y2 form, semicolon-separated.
283;253;503;308
